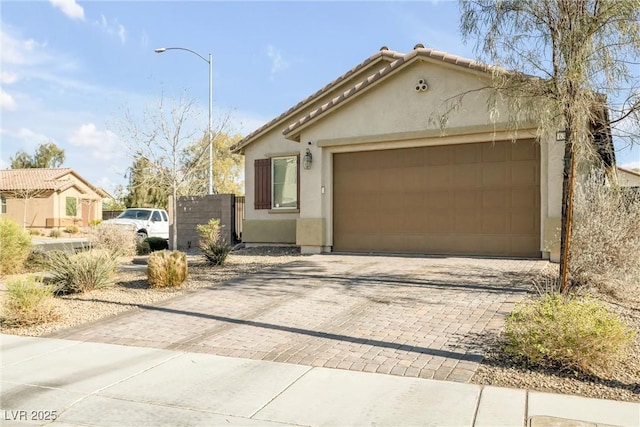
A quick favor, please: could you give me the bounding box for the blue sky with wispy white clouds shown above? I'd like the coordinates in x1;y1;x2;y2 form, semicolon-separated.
0;0;640;193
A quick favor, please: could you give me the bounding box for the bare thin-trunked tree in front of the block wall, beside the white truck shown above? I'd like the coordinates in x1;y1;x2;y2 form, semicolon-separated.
119;94;206;249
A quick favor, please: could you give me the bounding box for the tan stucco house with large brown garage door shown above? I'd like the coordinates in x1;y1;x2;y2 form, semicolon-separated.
231;45;610;260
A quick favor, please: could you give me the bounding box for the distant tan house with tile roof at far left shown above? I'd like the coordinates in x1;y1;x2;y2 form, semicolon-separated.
0;168;108;228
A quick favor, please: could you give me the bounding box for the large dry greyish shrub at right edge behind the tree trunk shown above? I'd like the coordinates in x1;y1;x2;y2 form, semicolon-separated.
570;174;640;292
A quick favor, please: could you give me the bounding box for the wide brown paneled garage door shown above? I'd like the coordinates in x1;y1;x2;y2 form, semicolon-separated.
333;141;541;258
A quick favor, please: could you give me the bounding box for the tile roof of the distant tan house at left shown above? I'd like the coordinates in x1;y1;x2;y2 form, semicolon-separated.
0;168;104;196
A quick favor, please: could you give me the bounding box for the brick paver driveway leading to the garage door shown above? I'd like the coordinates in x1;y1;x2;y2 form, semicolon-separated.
52;255;546;382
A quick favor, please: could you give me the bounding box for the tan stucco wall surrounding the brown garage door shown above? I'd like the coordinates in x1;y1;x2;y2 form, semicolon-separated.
243;56;563;258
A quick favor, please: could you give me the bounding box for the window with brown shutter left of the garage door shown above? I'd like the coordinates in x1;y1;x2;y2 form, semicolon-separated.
253;156;300;209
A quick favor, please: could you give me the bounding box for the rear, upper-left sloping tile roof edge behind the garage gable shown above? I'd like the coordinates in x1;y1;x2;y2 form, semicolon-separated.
230;46;403;152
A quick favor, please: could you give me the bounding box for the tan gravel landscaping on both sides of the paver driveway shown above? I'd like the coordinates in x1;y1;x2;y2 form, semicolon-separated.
0;247;640;402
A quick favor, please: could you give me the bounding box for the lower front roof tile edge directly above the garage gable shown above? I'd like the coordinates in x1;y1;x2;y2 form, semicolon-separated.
282;47;492;137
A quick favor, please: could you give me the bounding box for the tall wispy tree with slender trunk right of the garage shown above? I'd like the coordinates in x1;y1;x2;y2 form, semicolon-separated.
460;0;640;291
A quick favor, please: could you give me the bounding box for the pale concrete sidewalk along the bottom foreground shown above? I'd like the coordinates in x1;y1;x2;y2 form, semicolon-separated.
0;335;640;427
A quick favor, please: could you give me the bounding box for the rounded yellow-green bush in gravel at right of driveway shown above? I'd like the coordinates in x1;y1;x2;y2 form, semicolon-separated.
505;294;634;374
